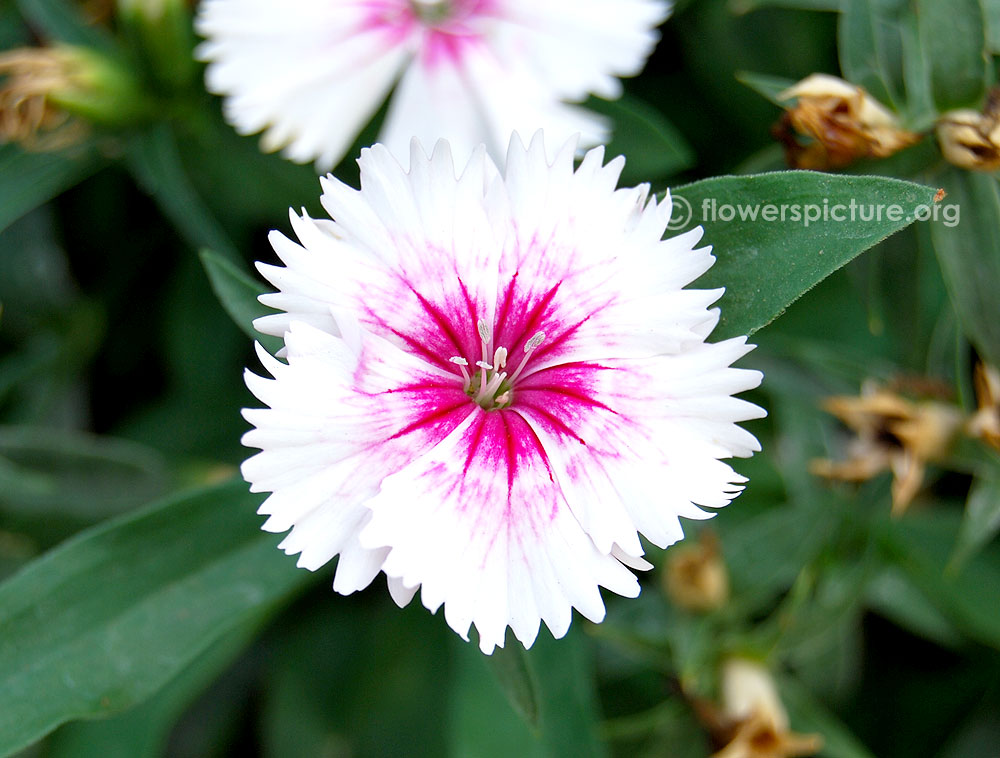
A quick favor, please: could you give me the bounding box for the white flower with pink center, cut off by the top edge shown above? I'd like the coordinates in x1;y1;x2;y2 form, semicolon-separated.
197;0;669;169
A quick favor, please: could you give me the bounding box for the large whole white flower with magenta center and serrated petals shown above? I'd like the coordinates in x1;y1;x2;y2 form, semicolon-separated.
243;133;763;652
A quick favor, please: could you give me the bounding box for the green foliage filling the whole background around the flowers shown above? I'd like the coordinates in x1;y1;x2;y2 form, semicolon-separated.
0;0;1000;758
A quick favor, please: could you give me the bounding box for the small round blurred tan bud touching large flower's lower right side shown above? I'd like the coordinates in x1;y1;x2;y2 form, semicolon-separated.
664;530;729;613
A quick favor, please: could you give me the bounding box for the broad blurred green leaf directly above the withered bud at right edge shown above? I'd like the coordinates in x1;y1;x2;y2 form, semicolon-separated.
914;0;989;111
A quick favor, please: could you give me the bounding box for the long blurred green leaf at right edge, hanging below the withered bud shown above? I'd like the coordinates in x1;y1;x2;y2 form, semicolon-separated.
928;167;1000;365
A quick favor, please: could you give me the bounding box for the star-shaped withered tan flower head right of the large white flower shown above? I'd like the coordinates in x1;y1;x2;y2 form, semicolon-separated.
810;383;962;516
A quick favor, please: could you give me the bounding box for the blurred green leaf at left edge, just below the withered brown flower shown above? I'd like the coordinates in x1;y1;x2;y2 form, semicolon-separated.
0;144;103;236
